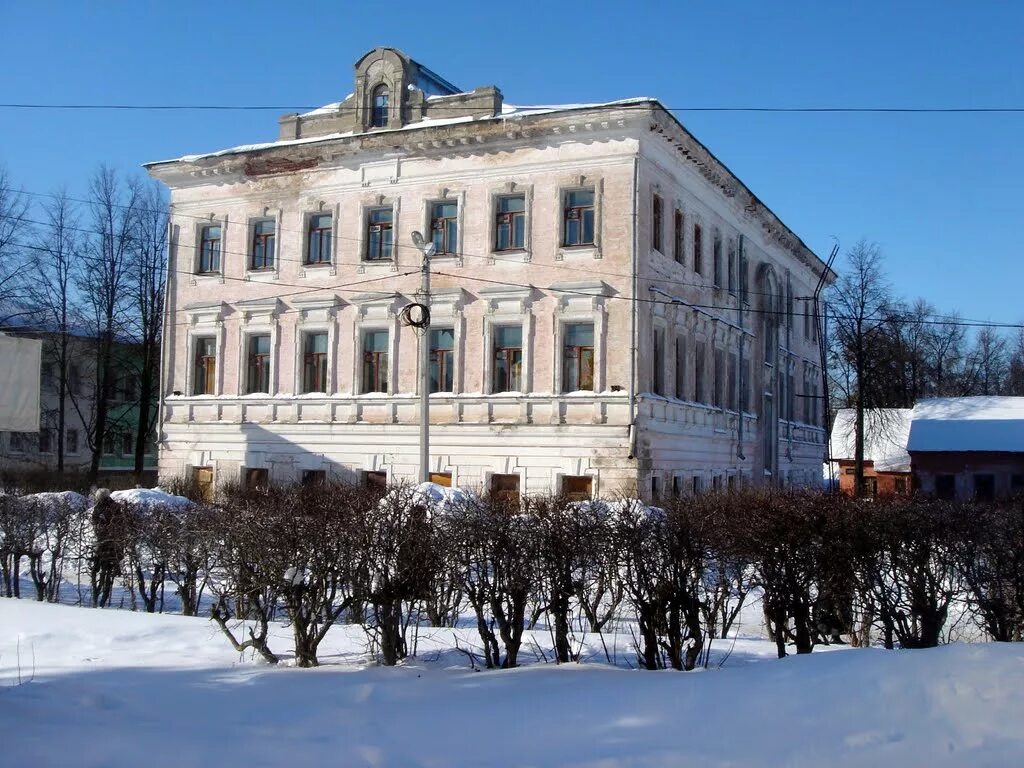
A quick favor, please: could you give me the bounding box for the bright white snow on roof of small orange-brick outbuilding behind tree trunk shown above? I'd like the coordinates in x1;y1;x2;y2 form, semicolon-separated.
829;408;911;472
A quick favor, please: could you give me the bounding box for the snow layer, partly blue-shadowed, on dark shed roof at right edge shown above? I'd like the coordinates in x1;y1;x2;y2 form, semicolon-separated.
907;396;1024;453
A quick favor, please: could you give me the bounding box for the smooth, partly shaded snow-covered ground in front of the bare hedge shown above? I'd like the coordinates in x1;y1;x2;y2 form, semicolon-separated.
0;599;1024;768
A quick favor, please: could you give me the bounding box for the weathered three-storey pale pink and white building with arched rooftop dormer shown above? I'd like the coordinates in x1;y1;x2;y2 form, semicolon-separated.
146;48;835;497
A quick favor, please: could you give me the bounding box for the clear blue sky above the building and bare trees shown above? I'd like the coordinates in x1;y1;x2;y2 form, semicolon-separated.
0;0;1024;322
